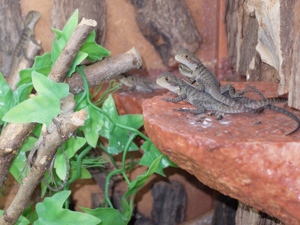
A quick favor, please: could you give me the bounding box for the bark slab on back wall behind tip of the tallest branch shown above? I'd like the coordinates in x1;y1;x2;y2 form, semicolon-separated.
51;0;106;45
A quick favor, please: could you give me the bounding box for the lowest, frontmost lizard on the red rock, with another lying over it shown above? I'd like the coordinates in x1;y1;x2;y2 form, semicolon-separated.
156;72;300;135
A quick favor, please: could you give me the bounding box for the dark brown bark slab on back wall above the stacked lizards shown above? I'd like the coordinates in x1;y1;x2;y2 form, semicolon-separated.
131;0;201;67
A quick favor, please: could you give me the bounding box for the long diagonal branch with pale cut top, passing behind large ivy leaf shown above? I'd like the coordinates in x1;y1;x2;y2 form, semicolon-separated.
0;18;96;190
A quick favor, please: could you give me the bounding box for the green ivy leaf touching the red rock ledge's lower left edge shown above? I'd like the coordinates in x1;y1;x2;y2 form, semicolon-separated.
139;141;177;176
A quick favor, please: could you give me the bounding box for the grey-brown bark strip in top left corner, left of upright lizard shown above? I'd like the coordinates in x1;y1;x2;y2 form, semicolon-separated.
0;0;23;77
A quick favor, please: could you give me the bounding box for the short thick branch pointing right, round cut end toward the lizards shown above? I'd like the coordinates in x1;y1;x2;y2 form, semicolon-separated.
66;48;142;94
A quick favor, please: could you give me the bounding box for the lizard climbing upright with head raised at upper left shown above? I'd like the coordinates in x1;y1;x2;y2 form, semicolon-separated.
9;11;41;89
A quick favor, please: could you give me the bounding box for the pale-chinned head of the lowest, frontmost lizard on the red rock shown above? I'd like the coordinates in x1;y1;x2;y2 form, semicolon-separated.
156;72;180;93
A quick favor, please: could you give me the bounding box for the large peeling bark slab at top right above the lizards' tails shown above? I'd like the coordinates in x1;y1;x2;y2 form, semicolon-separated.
226;0;300;109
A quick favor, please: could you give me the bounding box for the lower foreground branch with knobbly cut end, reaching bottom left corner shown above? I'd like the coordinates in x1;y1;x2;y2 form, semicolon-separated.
0;95;87;225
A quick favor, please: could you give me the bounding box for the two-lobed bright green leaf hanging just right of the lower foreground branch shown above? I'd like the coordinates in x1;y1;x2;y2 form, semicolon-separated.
54;137;86;180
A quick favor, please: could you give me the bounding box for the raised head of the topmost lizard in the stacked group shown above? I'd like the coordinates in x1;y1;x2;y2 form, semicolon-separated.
175;48;201;71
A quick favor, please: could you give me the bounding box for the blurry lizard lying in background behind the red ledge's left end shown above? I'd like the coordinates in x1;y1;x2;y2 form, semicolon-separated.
119;74;161;92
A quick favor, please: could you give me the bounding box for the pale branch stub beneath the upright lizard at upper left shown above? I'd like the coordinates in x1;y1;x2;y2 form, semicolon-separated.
7;40;42;90
